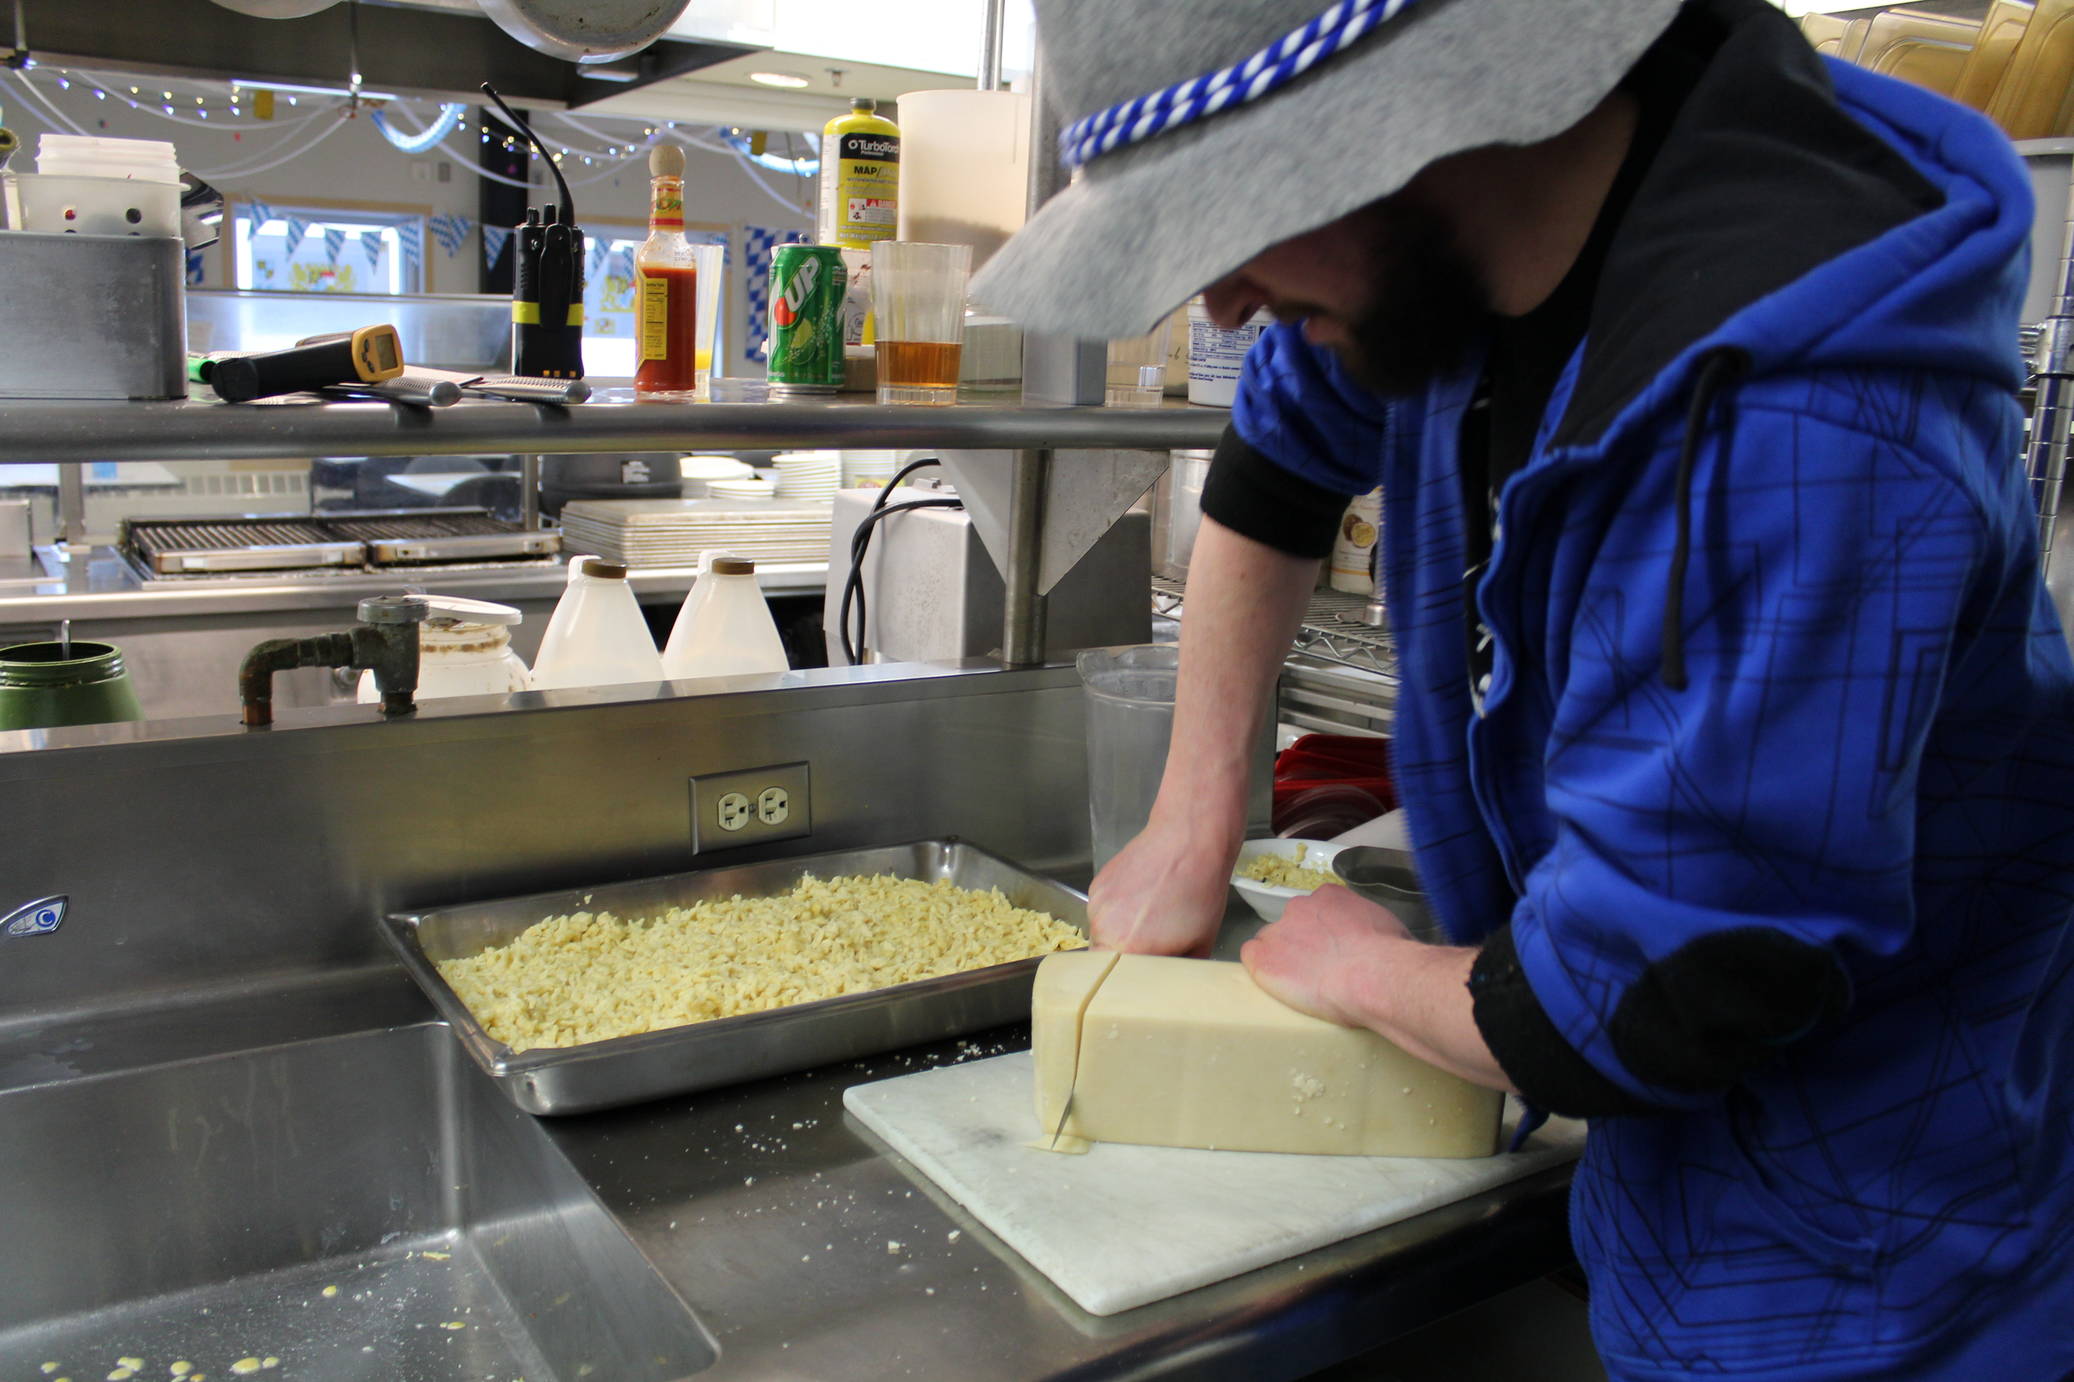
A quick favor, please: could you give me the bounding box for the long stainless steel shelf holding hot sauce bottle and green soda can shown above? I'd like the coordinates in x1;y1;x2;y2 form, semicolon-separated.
0;390;1232;463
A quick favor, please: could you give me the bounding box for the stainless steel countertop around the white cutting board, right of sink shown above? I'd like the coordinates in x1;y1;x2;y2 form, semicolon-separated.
548;1029;1570;1382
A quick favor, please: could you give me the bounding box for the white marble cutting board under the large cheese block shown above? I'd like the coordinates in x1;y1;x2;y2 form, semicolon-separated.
842;1052;1585;1316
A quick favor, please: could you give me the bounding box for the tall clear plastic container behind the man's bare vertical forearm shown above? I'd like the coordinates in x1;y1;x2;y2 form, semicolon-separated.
1074;643;1180;872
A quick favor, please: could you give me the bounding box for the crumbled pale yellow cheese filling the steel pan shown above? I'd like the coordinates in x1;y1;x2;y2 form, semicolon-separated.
440;876;1087;1050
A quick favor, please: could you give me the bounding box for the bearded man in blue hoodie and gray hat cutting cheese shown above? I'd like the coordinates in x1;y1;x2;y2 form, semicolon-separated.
975;0;2074;1382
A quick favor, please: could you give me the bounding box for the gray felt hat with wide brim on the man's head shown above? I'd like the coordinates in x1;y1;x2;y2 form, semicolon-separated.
973;0;1680;338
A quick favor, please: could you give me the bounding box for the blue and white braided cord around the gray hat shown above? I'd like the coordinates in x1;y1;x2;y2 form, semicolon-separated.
1058;0;1419;168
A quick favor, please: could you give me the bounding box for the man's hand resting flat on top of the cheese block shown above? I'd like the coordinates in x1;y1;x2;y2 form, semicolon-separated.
1238;884;1417;1027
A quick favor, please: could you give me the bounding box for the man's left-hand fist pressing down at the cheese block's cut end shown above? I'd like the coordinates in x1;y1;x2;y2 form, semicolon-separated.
1087;822;1232;957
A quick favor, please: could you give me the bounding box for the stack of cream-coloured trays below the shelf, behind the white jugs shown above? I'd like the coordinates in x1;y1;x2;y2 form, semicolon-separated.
562;498;830;566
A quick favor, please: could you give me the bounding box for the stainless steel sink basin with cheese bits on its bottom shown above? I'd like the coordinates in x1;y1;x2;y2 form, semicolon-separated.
0;1023;716;1382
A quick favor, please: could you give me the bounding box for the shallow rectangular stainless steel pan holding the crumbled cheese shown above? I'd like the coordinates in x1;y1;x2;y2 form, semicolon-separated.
382;838;1087;1114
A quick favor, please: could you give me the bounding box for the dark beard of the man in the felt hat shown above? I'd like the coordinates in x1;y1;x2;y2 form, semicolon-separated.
1340;203;1491;394
